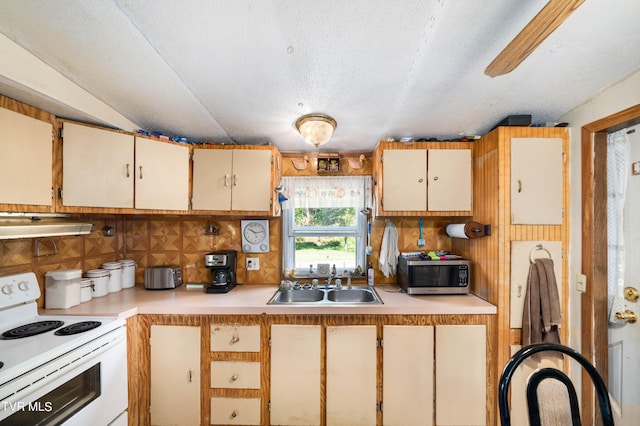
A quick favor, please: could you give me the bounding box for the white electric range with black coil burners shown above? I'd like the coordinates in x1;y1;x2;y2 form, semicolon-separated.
0;272;128;426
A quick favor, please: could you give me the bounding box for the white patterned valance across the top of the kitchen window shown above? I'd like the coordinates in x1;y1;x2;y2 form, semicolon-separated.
282;176;371;209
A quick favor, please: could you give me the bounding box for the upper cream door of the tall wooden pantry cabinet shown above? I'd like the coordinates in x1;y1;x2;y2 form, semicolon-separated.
511;138;563;225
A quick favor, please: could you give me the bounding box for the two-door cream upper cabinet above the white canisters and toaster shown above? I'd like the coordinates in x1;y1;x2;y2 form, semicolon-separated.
58;122;189;212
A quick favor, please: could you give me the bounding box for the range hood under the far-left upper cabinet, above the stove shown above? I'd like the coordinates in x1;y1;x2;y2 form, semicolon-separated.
0;213;94;240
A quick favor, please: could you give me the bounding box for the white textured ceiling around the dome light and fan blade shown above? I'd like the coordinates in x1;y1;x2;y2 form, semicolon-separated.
0;0;640;151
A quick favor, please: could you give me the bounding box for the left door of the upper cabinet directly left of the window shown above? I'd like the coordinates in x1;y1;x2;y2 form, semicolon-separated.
191;148;233;210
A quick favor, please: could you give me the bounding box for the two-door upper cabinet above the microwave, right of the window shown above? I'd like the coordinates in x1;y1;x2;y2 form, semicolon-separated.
374;142;472;216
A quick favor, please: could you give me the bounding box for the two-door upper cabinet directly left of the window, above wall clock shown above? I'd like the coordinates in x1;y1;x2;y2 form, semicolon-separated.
192;146;280;216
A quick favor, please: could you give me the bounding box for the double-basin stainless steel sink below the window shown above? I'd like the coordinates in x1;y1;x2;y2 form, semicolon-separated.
267;286;382;306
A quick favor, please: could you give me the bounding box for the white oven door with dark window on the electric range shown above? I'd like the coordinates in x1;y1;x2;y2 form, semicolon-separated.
0;329;128;426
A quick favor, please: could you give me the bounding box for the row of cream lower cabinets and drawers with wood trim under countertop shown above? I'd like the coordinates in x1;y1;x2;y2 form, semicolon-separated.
138;315;490;426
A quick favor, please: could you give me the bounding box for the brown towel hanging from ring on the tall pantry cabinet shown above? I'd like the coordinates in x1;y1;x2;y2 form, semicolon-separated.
522;259;562;346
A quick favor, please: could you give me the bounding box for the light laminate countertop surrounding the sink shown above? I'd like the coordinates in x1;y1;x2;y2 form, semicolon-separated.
39;285;496;318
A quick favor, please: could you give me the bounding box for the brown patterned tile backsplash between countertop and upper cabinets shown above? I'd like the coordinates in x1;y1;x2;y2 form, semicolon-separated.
0;215;451;307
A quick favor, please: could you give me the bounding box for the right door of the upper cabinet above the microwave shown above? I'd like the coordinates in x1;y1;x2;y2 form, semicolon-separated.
427;149;471;211
